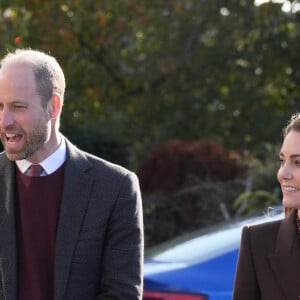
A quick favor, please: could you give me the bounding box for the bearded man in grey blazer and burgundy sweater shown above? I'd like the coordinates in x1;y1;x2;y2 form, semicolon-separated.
0;49;143;300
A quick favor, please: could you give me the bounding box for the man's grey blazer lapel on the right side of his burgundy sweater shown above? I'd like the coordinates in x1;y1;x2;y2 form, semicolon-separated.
54;141;93;300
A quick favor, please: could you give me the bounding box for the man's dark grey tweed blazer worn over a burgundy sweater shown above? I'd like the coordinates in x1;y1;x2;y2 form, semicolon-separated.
0;139;143;300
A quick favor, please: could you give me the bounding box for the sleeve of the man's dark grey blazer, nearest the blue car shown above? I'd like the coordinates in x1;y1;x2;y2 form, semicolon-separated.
97;172;144;300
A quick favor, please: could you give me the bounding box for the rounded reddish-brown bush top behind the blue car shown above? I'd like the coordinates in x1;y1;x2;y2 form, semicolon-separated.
138;139;242;193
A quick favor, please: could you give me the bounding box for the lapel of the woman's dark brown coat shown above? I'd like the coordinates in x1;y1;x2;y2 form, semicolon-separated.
269;210;300;300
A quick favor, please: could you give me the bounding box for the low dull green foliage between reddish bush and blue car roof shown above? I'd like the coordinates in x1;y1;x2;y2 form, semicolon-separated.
143;179;244;247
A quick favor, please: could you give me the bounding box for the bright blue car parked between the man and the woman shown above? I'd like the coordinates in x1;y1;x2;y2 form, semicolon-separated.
143;208;284;300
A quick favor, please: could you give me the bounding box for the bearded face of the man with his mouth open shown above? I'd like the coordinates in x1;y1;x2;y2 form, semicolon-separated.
0;64;51;162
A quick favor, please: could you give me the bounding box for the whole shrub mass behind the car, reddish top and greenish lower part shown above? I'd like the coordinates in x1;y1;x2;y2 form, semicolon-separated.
138;140;244;247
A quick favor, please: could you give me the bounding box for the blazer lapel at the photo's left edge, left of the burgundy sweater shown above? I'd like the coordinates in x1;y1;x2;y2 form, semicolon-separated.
0;156;17;300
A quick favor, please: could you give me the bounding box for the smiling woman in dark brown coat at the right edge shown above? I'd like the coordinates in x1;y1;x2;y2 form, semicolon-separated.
233;113;300;300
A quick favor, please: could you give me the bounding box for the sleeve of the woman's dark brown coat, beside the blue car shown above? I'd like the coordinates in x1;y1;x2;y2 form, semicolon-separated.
232;226;261;300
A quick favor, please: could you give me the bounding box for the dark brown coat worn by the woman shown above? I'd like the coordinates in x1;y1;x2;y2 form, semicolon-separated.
233;209;300;300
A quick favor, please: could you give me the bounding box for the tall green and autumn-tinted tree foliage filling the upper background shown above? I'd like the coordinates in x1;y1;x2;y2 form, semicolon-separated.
0;0;300;167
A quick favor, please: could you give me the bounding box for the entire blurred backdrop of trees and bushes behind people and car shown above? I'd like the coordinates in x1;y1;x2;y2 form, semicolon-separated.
0;0;300;246
